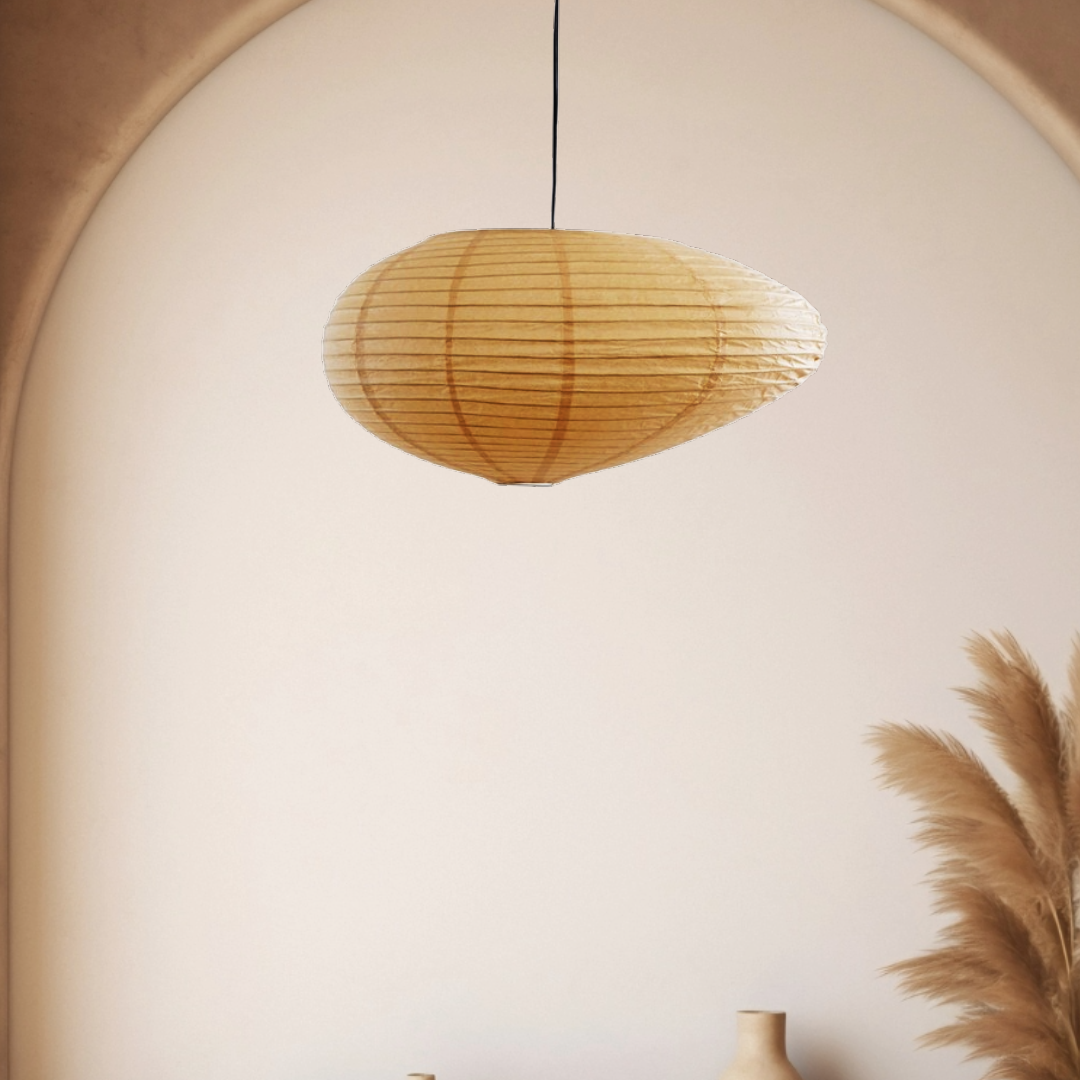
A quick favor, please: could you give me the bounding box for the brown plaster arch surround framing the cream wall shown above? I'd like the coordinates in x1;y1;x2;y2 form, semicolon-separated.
0;0;1080;1076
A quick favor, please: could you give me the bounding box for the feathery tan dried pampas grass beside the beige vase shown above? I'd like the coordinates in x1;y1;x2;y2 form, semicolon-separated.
870;634;1080;1080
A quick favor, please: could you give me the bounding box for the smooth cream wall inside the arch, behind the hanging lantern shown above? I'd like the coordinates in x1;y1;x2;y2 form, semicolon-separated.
8;0;1080;1080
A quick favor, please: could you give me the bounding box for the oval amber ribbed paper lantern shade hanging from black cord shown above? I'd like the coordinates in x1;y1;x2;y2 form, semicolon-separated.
325;229;825;484
